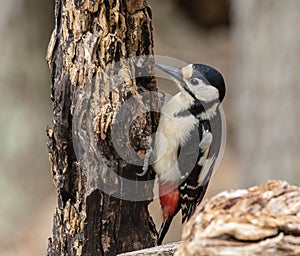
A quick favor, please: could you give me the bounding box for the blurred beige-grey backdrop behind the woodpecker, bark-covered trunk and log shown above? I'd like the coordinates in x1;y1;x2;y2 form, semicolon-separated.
0;0;300;256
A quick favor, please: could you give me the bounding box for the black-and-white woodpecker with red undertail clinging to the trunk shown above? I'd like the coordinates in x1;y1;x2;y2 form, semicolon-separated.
153;64;226;245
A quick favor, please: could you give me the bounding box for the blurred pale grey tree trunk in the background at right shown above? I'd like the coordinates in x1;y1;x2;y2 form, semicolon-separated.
232;0;300;185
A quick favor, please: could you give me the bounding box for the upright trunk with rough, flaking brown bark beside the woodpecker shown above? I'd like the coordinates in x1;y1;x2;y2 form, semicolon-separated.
47;0;158;256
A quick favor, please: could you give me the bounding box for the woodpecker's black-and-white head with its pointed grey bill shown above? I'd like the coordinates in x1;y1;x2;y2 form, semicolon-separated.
156;64;226;104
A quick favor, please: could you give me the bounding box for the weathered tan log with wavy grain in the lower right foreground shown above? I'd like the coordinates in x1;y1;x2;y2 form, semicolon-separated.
122;181;300;256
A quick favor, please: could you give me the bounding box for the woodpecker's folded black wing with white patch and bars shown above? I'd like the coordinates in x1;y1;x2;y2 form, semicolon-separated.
178;109;222;222
